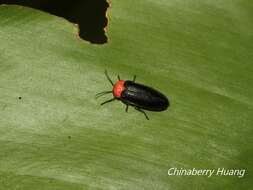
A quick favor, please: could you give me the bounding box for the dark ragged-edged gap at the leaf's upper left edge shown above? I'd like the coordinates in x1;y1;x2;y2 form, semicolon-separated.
0;0;109;44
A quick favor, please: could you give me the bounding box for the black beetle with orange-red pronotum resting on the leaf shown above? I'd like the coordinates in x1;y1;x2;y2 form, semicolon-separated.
96;70;169;120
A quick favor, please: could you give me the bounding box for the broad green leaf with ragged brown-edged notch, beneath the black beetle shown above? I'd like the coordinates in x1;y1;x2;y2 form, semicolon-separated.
0;0;253;190
